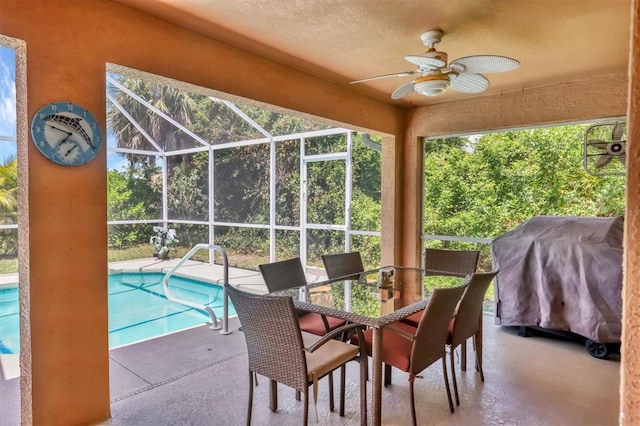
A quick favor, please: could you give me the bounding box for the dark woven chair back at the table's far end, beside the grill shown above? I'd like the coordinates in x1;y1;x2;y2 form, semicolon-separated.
424;249;480;278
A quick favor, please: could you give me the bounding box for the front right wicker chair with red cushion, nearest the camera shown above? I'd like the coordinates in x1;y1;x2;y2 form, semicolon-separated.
352;284;467;426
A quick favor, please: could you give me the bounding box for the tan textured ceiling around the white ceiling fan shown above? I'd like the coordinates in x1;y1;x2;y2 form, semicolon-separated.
118;0;631;106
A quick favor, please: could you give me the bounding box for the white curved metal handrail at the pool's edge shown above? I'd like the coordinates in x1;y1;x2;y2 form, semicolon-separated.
162;243;231;334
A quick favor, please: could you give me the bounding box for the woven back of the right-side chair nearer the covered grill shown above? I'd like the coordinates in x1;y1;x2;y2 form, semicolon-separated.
449;270;498;347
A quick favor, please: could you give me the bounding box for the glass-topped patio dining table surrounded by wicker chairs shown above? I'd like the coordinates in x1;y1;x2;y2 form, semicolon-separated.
273;266;462;425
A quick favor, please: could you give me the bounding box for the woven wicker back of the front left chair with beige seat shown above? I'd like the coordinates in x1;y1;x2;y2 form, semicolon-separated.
225;283;308;392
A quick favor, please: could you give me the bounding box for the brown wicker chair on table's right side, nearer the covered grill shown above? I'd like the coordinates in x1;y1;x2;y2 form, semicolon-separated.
447;270;498;405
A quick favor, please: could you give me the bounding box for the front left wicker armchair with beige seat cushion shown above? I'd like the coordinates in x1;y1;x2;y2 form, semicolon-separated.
225;284;367;425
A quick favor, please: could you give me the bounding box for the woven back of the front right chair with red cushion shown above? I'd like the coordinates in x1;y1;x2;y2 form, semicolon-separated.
409;284;467;375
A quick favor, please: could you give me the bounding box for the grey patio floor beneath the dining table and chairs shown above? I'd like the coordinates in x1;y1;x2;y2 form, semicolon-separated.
0;258;620;426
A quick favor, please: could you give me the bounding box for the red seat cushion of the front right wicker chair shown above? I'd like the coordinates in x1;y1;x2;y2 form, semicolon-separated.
351;321;417;371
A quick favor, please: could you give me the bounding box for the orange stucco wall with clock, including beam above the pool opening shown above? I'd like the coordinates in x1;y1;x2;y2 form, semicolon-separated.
0;0;403;424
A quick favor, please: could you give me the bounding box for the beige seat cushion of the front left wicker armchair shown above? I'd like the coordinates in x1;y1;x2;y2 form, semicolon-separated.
302;332;359;382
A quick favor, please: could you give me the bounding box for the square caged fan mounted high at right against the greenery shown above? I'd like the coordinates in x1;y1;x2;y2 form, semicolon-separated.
582;121;627;176
